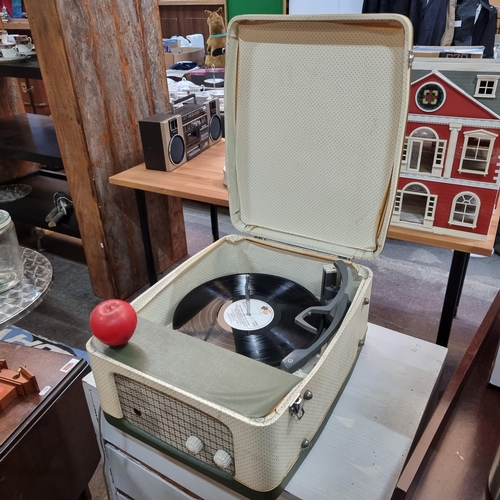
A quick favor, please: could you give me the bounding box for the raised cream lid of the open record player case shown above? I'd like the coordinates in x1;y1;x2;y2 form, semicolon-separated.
224;14;412;259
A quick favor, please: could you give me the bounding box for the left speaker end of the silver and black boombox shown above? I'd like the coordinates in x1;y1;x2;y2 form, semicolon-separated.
139;113;186;172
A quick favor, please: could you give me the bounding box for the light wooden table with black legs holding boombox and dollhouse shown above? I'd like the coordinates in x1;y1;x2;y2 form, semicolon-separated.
109;140;500;346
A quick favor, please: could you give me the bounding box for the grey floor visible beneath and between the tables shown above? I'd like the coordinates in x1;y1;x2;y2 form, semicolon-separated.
9;202;500;500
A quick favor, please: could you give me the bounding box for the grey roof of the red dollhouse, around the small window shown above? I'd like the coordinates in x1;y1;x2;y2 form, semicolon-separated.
411;69;500;117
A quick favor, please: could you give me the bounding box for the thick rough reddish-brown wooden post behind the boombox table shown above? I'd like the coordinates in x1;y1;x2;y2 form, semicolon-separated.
26;0;187;298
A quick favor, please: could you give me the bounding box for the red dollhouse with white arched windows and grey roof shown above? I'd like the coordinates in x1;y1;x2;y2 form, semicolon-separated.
392;58;500;240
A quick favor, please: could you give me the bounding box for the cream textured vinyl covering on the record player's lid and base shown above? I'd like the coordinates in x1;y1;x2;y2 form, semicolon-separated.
87;15;411;491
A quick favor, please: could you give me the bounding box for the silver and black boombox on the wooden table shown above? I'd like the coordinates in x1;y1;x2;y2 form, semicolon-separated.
139;96;222;172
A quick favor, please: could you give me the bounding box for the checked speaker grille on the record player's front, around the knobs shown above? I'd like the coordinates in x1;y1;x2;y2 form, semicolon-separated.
115;374;234;475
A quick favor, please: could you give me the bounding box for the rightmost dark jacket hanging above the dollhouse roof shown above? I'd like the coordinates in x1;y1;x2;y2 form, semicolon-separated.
453;0;497;58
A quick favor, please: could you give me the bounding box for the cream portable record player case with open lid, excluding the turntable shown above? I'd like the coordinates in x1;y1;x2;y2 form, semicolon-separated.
87;15;412;498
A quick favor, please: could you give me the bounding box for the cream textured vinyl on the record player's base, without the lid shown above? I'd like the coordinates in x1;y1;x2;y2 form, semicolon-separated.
87;236;372;491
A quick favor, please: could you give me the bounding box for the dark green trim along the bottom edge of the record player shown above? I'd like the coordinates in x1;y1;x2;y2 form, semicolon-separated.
103;335;366;500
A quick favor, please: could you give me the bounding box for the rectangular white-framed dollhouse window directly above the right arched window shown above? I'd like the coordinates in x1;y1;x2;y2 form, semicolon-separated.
458;130;498;175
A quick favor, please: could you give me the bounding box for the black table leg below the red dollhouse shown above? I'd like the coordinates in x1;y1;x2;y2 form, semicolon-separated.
436;250;470;347
